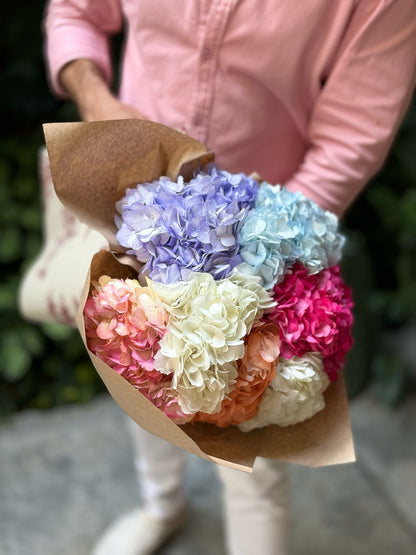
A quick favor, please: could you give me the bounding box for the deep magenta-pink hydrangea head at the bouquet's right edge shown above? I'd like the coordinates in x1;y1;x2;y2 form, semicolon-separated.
265;264;353;381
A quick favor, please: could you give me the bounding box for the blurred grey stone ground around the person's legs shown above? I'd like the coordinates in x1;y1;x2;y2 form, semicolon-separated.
0;396;416;555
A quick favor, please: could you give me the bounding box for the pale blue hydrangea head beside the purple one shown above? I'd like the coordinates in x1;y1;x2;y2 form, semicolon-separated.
238;182;344;289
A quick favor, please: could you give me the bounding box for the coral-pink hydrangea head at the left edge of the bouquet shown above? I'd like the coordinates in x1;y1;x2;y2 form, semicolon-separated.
84;276;168;383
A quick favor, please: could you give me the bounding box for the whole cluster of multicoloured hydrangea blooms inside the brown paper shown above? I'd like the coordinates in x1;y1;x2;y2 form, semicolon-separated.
43;122;352;472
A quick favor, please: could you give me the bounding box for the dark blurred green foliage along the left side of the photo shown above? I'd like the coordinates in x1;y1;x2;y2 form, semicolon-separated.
0;0;103;415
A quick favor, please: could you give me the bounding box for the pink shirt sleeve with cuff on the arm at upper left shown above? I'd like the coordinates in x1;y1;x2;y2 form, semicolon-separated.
43;0;123;96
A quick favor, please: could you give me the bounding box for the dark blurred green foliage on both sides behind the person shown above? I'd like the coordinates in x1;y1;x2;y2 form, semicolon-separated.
0;1;416;414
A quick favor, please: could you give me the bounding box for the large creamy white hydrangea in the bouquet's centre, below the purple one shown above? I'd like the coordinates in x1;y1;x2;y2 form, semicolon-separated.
149;273;271;414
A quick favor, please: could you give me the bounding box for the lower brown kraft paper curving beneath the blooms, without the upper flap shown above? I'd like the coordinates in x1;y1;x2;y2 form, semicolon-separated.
78;251;355;472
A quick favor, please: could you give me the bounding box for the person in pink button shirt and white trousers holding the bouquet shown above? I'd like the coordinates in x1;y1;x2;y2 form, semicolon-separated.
45;0;416;555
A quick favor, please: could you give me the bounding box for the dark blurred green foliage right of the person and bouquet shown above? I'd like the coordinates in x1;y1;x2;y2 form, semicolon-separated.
344;102;416;404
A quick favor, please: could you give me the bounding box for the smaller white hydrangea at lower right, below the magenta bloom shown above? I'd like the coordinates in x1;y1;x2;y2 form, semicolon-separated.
238;353;330;432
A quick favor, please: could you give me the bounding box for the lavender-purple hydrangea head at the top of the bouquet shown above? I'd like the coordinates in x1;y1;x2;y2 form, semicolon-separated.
116;166;258;283
